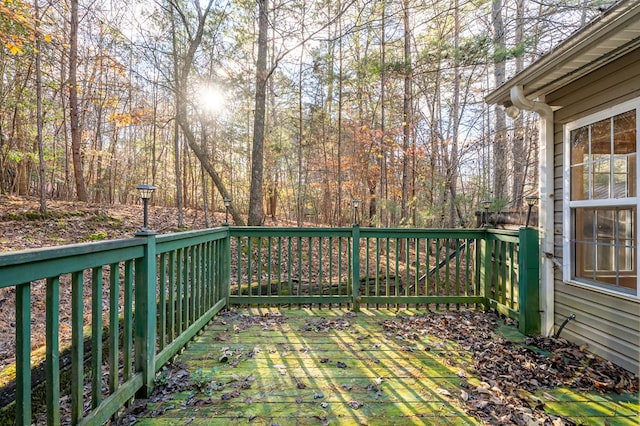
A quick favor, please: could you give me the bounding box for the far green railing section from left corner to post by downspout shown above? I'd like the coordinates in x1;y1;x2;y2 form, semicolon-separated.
229;226;539;334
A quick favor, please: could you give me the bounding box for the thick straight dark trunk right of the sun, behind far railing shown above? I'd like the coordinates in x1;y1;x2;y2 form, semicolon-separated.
247;0;269;226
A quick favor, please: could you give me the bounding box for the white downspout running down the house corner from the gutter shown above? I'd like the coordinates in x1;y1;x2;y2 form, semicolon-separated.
510;86;554;336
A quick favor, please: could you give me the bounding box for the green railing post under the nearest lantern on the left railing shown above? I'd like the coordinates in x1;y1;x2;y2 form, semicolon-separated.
134;231;156;398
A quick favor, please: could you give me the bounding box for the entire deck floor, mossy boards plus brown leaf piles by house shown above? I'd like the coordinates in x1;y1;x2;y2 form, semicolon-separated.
119;309;640;426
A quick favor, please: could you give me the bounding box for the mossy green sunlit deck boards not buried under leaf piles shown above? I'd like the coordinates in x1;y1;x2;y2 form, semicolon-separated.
125;309;640;425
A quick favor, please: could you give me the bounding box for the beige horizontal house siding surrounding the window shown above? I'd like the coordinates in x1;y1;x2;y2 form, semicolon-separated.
545;49;640;373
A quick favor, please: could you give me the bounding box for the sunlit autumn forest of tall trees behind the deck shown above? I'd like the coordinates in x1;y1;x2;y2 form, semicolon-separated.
0;0;614;227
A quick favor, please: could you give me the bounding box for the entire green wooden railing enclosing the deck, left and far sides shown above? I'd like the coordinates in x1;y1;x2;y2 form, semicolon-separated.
0;226;540;425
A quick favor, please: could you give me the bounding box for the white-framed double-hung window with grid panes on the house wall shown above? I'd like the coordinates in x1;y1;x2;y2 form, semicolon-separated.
563;98;640;296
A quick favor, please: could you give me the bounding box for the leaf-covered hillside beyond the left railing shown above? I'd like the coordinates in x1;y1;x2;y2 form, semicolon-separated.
0;196;218;372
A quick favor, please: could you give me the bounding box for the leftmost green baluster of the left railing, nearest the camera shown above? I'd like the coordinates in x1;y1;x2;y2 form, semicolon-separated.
15;283;31;425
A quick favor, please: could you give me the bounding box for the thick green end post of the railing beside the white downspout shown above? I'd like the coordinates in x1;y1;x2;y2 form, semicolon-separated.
518;228;540;335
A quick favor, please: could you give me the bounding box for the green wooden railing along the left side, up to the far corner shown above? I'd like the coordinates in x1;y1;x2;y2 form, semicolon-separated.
0;229;229;425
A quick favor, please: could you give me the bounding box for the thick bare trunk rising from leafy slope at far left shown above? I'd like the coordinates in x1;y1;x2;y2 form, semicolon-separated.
69;0;89;201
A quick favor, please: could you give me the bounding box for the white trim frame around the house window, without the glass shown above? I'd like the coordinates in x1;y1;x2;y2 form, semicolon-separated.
562;97;640;300
